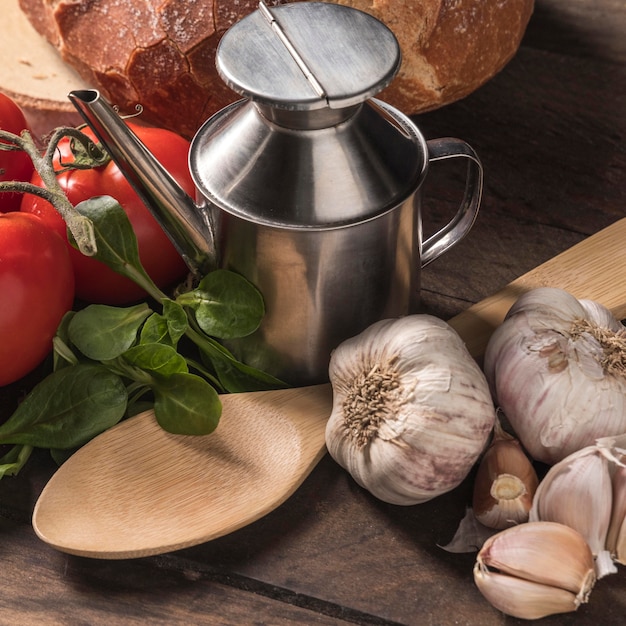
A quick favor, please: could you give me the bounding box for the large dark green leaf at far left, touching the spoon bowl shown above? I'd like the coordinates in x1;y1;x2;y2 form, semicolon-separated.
0;364;127;449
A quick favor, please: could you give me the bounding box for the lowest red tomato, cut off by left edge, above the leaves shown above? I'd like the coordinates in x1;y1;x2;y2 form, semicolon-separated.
0;212;74;386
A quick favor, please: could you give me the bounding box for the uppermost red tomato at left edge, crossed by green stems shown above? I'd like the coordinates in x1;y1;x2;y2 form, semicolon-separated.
0;93;33;212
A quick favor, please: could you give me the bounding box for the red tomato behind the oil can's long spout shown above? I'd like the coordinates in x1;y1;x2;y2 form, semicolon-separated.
21;124;190;305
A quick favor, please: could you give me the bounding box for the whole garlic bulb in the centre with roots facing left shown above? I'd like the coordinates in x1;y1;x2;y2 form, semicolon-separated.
326;315;495;505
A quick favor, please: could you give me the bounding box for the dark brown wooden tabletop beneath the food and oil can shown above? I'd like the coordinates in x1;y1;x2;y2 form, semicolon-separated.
0;0;626;626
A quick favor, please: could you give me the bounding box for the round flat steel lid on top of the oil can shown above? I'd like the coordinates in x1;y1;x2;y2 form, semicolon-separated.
216;2;401;110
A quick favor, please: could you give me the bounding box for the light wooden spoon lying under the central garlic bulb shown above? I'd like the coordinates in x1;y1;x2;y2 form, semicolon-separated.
33;219;626;559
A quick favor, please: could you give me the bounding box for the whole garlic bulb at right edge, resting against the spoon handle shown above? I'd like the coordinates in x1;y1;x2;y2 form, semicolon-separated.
484;287;626;464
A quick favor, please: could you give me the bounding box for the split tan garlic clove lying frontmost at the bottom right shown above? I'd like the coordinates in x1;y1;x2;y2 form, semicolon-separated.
474;522;596;619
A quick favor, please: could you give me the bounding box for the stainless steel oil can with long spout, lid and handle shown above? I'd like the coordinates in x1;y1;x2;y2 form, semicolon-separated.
68;2;482;384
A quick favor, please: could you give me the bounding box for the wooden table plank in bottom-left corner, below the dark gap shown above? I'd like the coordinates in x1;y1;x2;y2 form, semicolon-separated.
0;519;356;626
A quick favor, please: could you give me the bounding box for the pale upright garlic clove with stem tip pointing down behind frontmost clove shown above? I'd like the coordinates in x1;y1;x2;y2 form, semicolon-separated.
529;446;617;578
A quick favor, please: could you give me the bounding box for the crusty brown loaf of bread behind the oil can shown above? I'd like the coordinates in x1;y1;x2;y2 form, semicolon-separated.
19;0;533;137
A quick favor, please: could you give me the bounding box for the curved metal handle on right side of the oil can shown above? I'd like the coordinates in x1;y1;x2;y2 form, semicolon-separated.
421;137;483;267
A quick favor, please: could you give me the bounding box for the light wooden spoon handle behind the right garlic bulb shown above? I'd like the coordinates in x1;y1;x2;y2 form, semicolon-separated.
450;218;626;358
